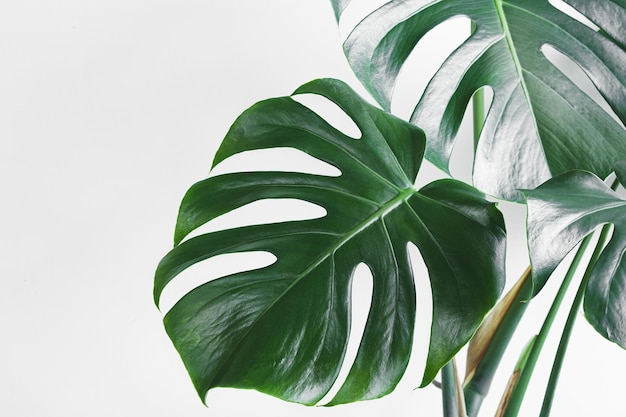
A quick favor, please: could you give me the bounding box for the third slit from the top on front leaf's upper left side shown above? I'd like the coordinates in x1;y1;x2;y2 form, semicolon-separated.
180;198;327;240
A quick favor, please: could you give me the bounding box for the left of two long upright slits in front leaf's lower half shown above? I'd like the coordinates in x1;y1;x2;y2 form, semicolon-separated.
319;263;374;404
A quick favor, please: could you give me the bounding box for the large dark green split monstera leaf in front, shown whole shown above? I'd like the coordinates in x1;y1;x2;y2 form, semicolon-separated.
154;80;505;404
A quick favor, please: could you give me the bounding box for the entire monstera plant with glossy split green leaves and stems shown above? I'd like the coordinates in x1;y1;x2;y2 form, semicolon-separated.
154;0;626;417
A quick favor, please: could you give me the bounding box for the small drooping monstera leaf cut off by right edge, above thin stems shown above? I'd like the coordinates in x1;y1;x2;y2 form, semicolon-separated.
525;171;626;348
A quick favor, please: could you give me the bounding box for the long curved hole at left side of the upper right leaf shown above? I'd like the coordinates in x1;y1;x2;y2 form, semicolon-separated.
391;16;471;120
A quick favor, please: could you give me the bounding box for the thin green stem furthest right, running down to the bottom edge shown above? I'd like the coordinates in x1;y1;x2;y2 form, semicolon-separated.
539;182;617;417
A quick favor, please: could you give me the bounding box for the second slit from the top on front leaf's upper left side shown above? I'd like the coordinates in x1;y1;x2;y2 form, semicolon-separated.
211;147;341;177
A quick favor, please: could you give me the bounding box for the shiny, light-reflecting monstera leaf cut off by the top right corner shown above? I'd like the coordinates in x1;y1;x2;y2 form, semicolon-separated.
332;0;626;200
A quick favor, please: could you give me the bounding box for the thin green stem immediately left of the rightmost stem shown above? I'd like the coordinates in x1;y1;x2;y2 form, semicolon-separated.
503;235;591;417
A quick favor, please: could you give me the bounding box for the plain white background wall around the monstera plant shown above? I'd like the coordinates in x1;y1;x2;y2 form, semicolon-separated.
0;0;626;417
